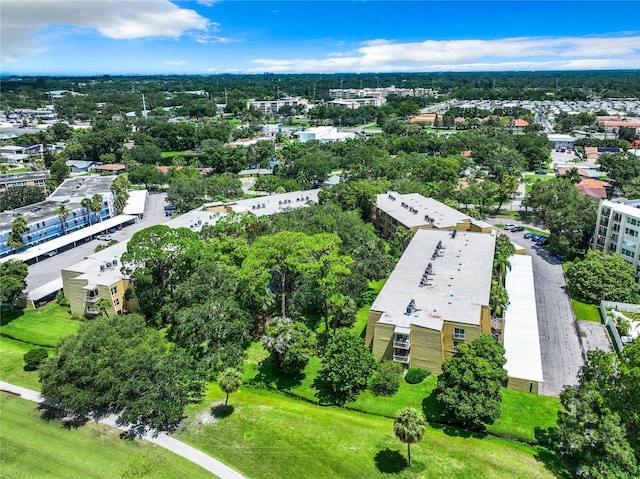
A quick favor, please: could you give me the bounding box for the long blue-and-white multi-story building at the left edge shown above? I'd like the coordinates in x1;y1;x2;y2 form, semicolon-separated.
0;176;116;257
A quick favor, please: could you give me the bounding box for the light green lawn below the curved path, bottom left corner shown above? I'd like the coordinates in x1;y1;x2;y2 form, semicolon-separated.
0;393;214;479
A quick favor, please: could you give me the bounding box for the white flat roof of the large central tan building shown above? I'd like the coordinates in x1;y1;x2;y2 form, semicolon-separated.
371;229;496;330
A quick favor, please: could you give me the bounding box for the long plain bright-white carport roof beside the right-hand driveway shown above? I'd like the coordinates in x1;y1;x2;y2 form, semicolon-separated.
503;255;543;383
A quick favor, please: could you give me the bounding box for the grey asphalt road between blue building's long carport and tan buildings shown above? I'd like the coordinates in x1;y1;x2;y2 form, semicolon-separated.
27;193;169;291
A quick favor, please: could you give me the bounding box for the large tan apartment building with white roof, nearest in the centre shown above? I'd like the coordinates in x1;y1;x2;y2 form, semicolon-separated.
365;229;496;374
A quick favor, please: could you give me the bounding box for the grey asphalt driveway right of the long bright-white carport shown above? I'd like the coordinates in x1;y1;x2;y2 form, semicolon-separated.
486;218;611;396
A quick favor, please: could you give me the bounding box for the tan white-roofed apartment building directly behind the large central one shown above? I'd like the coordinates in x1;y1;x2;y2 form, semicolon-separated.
371;191;493;242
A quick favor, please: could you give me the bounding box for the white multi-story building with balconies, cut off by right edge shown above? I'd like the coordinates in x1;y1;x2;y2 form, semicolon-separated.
593;199;640;278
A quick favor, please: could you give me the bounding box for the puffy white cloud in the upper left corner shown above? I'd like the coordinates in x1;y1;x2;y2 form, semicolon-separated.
0;0;215;62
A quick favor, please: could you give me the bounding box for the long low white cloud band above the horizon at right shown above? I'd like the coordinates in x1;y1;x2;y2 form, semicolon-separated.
248;33;640;72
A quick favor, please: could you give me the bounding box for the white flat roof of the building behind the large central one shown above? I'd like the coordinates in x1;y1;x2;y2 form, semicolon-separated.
376;191;480;229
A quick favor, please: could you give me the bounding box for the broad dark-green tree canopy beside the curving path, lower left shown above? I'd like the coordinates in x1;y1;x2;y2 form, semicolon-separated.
40;314;204;431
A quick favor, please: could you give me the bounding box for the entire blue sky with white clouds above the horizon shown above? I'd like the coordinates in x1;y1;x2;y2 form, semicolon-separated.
0;0;640;75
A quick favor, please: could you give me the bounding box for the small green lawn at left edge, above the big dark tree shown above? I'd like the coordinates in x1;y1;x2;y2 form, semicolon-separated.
0;303;82;347
